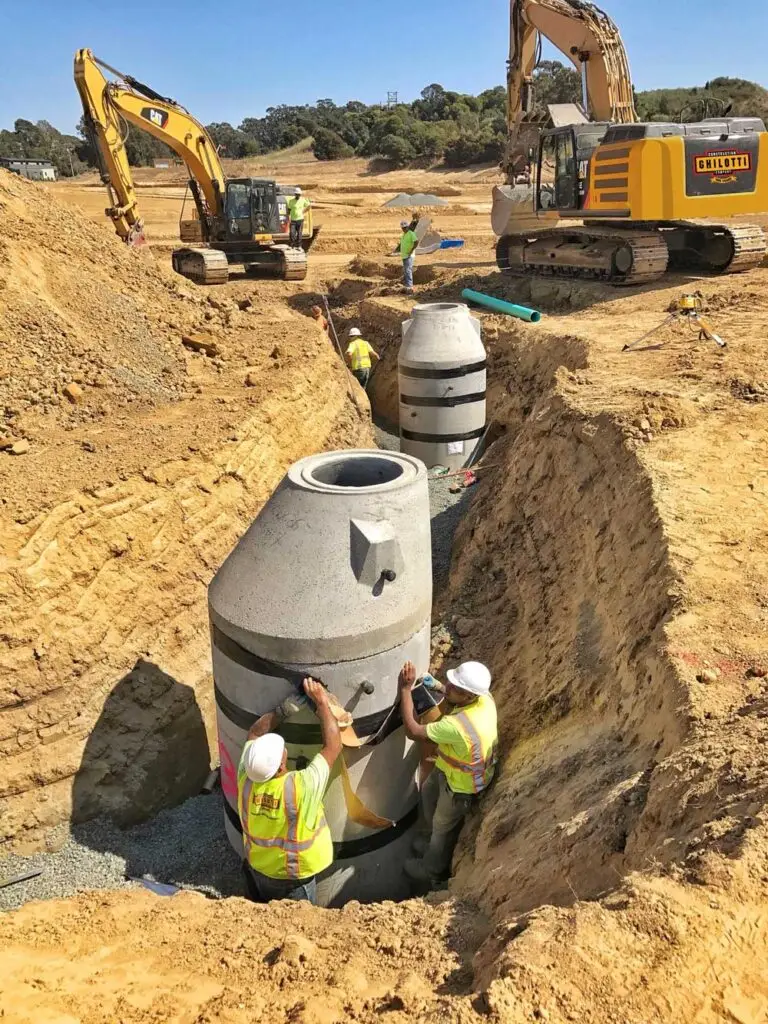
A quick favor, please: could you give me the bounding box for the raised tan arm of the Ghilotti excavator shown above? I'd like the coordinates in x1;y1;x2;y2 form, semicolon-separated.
507;0;637;161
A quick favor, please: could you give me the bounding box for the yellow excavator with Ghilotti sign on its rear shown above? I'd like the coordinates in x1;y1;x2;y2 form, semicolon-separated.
492;0;768;285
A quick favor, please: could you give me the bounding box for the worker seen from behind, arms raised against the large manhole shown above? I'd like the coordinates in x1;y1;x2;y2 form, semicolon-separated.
238;679;341;903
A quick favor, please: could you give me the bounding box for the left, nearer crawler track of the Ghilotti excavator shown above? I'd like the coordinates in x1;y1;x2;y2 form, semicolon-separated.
497;226;669;286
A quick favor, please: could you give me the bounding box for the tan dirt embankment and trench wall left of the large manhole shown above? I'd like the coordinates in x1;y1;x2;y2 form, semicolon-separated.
0;173;371;845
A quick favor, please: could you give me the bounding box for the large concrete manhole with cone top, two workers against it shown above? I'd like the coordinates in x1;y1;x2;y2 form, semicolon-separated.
209;450;432;905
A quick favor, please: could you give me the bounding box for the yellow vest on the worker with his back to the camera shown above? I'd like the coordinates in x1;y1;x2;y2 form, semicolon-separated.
238;771;334;880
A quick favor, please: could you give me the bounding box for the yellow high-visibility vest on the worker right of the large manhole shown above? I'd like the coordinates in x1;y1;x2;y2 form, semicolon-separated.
435;694;499;793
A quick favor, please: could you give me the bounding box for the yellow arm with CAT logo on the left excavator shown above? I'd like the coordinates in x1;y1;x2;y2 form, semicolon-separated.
75;49;225;243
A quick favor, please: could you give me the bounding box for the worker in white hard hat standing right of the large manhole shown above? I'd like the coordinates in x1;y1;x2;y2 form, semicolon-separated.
398;662;498;887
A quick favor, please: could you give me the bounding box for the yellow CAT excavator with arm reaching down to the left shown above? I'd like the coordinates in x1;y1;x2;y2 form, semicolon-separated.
75;49;319;285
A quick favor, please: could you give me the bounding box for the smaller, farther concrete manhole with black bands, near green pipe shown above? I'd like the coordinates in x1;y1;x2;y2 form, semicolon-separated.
398;302;485;469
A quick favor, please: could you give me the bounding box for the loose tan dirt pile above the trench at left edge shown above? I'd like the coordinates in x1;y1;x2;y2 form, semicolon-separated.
0;171;208;448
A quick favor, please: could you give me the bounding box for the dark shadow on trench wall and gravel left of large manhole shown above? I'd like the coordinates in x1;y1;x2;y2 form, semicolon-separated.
72;658;243;895
